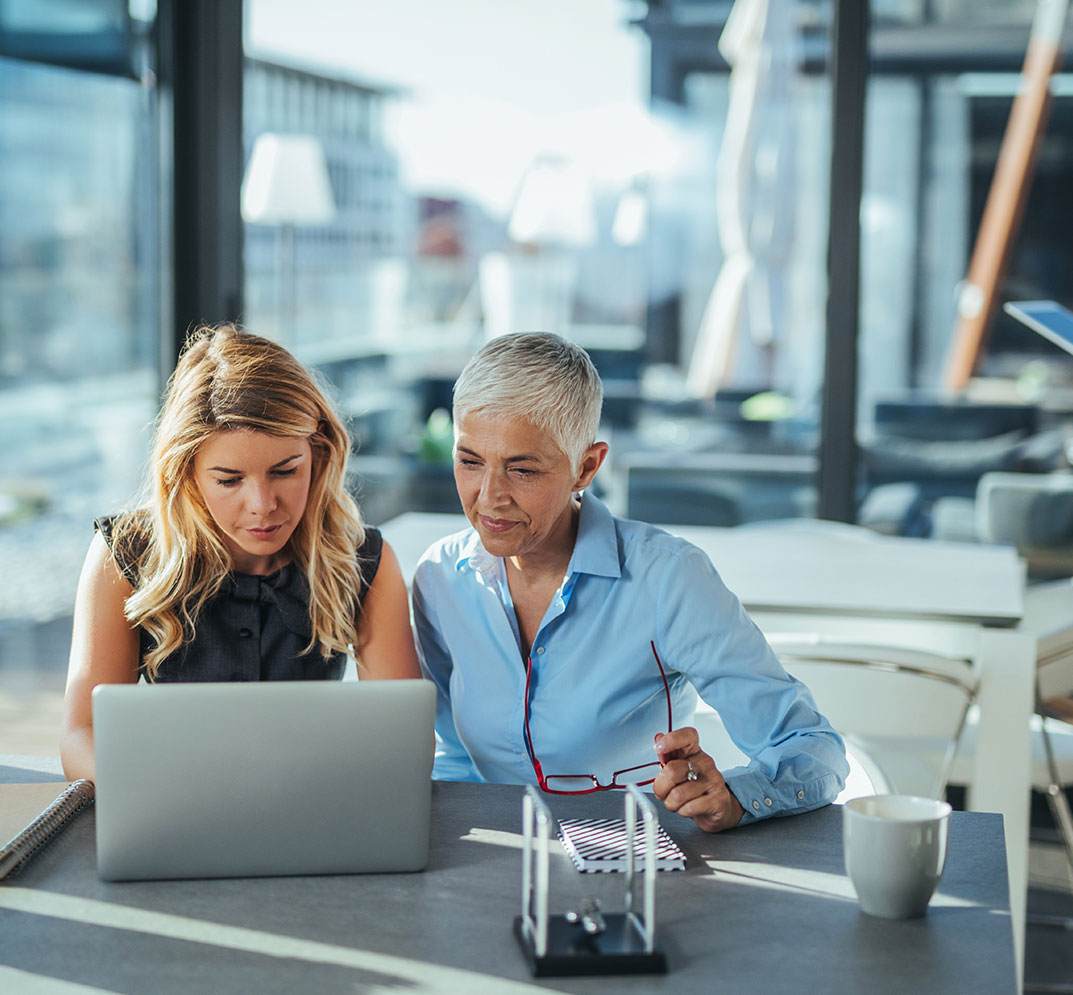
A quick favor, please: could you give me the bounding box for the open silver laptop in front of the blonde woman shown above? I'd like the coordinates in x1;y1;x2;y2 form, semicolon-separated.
93;681;436;881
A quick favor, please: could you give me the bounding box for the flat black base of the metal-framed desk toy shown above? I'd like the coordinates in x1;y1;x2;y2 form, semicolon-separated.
514;912;667;978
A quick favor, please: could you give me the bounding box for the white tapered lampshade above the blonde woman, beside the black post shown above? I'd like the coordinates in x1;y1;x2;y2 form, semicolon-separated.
241;132;336;224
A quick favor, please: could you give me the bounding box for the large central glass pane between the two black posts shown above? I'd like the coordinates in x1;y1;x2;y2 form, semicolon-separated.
245;0;829;525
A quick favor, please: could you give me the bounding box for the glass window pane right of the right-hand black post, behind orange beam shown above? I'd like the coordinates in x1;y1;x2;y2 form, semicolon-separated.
858;0;1073;558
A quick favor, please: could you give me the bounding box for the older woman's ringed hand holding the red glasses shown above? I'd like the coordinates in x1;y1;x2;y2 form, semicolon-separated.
652;726;745;833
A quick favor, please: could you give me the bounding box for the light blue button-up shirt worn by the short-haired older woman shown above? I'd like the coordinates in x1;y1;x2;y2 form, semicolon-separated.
413;494;849;823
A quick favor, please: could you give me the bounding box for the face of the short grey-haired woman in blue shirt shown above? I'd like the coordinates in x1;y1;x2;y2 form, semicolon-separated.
455;412;607;557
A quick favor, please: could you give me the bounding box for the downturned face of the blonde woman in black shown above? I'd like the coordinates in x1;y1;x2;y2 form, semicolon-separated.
194;431;312;574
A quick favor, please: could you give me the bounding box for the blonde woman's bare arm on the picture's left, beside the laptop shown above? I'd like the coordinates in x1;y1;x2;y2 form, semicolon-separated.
60;535;138;780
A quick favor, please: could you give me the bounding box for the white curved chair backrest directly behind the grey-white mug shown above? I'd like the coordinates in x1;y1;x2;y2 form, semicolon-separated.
768;633;976;798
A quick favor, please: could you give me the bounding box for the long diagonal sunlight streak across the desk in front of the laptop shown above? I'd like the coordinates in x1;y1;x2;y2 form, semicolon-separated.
0;887;543;995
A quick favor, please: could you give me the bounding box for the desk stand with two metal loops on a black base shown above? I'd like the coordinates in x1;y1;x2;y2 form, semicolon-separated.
514;785;667;978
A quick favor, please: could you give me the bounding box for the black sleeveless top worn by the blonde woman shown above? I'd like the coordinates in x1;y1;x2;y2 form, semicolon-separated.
93;517;383;684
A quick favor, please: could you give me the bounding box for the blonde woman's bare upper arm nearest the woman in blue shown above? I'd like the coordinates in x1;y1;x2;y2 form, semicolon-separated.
357;542;421;681
